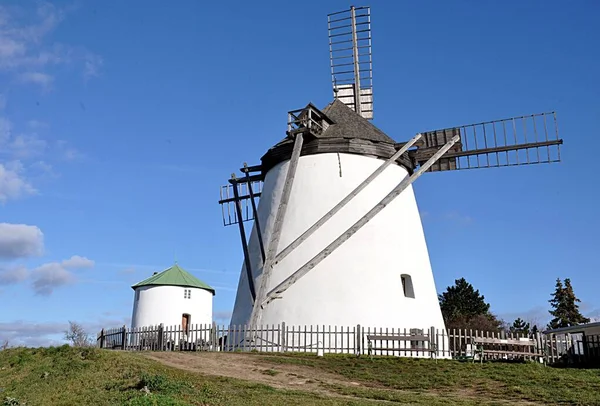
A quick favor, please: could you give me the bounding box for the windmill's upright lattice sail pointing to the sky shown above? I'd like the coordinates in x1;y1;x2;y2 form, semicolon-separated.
327;6;373;119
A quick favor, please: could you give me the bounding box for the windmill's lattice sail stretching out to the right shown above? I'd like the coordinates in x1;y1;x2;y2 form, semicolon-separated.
409;112;563;171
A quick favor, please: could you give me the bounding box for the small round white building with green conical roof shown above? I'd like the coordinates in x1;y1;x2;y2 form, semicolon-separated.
131;264;215;331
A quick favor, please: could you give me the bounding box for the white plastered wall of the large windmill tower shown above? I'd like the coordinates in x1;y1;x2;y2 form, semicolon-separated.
231;153;444;356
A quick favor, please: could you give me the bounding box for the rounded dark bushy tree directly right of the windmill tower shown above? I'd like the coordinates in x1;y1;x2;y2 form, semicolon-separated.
438;278;502;331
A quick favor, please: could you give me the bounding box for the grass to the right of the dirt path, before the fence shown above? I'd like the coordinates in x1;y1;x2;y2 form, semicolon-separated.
263;355;600;405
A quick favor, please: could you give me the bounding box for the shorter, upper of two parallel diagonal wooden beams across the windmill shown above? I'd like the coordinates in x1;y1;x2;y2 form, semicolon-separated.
273;134;422;265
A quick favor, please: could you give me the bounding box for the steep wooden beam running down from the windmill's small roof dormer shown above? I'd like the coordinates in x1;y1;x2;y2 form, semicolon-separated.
250;133;304;326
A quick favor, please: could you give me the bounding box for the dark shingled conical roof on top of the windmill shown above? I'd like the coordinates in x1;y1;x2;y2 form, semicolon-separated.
317;99;396;144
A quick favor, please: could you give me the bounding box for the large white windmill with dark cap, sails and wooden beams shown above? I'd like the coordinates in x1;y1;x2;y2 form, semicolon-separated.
219;7;562;348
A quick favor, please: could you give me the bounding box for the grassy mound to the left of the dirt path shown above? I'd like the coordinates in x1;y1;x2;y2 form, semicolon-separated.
0;346;370;406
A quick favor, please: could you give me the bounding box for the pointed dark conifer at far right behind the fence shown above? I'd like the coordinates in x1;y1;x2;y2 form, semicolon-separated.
548;278;590;329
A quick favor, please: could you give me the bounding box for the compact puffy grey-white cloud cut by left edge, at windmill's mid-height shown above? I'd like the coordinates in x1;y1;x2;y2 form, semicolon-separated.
0;223;44;259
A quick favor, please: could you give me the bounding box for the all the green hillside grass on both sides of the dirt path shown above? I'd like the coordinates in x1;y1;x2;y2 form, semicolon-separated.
0;346;600;406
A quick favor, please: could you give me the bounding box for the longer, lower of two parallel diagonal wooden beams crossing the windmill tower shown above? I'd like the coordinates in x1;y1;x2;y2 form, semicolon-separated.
254;135;460;308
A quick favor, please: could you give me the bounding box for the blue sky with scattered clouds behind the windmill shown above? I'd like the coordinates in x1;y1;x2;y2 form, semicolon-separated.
0;0;600;345
